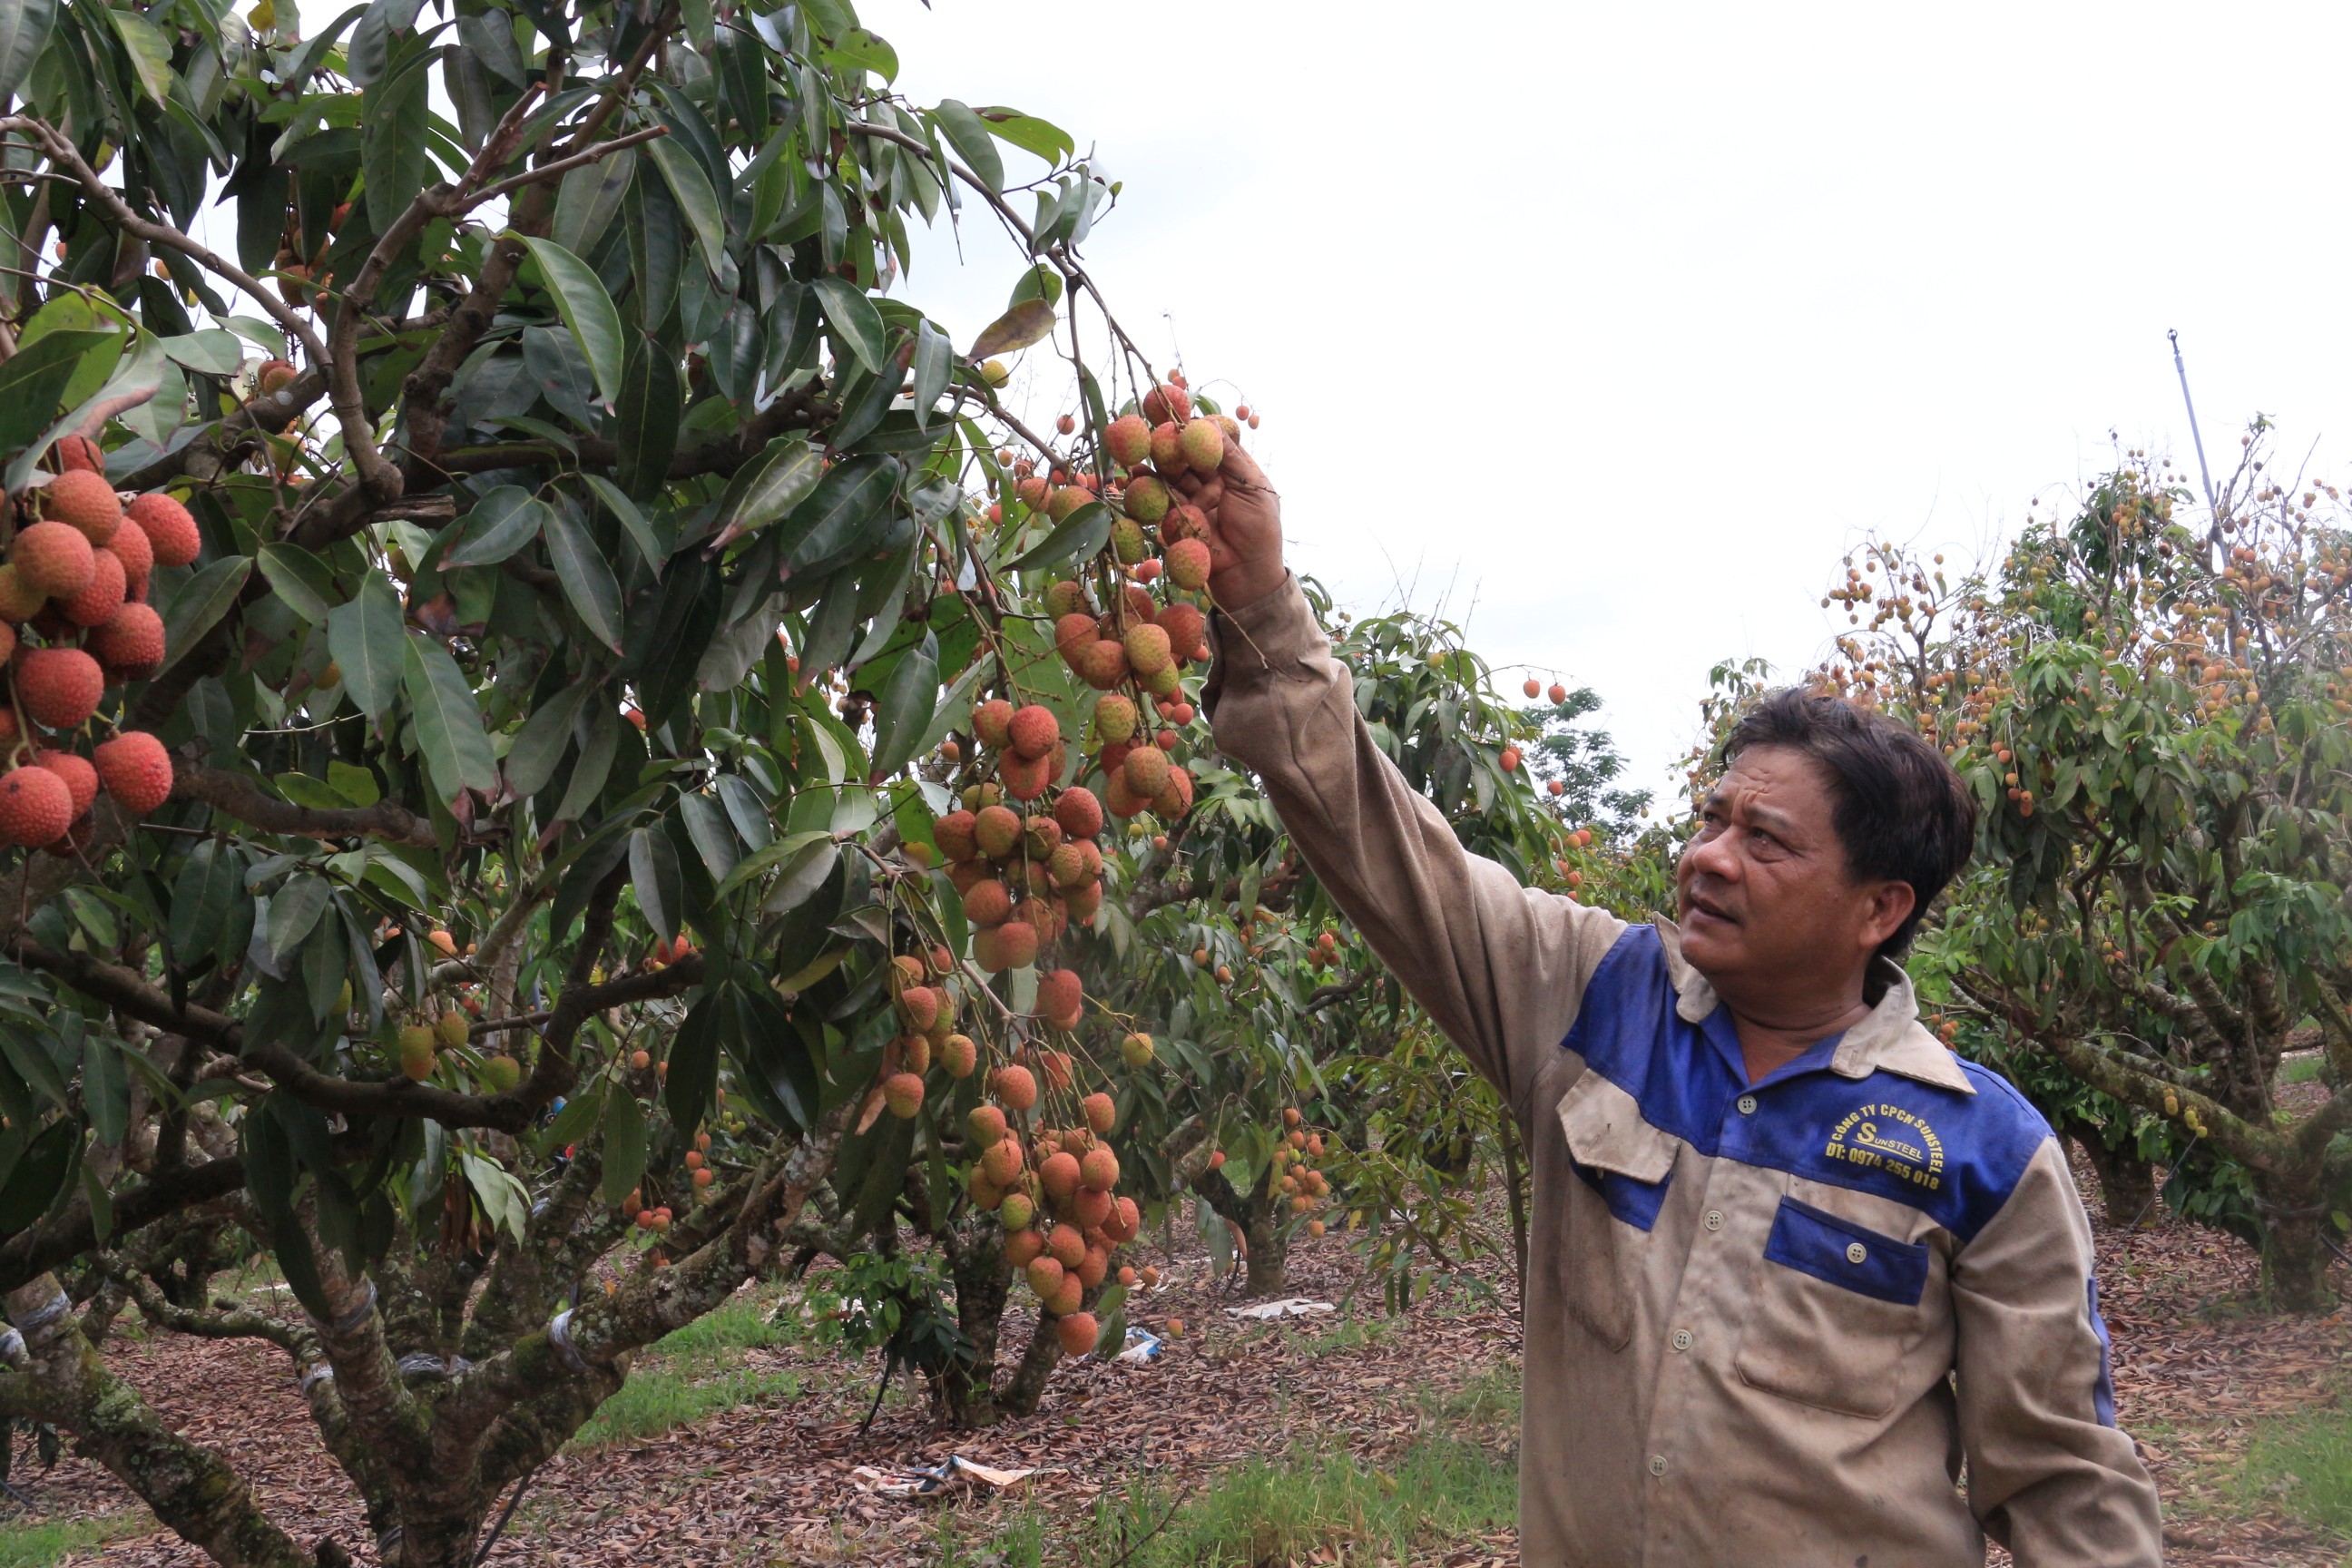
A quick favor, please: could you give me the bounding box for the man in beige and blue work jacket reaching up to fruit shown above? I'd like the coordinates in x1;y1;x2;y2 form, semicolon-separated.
1191;442;2164;1568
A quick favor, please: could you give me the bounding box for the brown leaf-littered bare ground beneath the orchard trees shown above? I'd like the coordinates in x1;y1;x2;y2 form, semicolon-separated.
16;1184;2352;1568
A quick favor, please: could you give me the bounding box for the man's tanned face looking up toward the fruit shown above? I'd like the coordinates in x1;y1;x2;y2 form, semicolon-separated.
1675;745;1912;999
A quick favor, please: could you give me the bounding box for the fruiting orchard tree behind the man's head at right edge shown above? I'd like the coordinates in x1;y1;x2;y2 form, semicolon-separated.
1778;426;2352;1312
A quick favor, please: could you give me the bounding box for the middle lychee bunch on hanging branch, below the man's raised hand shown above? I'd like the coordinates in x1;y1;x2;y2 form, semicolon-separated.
931;757;1103;968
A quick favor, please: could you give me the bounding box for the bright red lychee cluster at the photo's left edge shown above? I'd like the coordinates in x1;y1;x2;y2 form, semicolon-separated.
0;446;185;856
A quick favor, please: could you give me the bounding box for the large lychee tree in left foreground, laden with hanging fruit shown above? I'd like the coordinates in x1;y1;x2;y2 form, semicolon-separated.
0;0;1289;1565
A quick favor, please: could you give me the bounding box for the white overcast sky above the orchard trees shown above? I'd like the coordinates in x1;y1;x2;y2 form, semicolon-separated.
861;0;2352;785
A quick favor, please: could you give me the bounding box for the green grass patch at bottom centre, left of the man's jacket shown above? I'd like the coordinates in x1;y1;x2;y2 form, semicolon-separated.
938;1368;1519;1568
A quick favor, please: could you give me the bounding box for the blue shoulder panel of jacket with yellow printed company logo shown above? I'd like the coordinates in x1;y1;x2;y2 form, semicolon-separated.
1562;926;2051;1243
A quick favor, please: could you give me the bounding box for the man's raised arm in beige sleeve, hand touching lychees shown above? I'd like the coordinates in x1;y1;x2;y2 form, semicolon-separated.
1188;439;1625;1117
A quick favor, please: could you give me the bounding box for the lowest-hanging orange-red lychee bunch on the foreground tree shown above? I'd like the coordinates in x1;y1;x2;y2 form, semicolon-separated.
965;1067;1143;1357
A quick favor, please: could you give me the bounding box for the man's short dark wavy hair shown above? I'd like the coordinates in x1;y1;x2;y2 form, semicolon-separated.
1724;686;1975;959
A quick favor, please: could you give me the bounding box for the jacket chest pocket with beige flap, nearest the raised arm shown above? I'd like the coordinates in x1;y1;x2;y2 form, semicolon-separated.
1559;1070;1680;1349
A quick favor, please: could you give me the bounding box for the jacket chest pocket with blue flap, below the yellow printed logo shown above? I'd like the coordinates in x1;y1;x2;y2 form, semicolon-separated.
1733;1197;1934;1417
